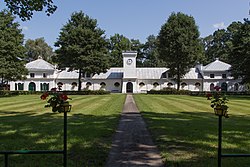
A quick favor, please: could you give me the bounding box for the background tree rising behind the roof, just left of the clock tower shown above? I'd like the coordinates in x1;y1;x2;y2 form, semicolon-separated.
108;34;131;67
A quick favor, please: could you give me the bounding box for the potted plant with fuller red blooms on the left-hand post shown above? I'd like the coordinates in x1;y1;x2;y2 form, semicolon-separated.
40;89;71;113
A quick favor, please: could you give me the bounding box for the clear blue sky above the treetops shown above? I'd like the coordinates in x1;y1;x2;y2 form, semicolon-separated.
0;0;250;49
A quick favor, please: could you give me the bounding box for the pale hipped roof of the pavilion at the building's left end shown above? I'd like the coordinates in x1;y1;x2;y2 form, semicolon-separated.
25;59;55;71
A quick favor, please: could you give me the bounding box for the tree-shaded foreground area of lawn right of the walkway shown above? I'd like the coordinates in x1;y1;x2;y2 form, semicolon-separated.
142;111;250;167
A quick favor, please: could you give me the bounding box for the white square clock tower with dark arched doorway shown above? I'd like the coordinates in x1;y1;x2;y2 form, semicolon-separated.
122;51;137;93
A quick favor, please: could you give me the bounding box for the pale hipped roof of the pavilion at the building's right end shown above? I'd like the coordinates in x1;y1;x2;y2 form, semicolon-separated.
203;59;231;71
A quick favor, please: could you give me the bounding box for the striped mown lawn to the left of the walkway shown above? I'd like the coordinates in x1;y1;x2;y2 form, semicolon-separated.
0;94;125;167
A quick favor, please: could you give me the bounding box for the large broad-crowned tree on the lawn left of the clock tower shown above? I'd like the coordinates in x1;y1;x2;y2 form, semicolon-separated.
55;11;109;91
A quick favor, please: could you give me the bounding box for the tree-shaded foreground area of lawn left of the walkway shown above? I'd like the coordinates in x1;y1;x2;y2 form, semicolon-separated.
0;111;119;167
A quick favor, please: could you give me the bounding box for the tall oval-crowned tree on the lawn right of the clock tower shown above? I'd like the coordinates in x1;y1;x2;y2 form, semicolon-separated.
158;12;202;90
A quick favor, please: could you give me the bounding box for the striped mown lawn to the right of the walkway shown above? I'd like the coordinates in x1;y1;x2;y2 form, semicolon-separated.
134;95;250;167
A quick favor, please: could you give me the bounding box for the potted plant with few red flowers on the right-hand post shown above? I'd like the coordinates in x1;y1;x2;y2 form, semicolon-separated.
207;86;229;118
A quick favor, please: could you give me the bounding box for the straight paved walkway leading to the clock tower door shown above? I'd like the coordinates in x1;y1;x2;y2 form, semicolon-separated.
106;94;163;167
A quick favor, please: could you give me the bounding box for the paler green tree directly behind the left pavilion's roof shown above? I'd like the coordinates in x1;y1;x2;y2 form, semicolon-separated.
25;38;54;62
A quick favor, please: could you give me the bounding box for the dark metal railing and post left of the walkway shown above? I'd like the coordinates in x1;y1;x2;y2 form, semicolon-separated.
0;111;68;167
